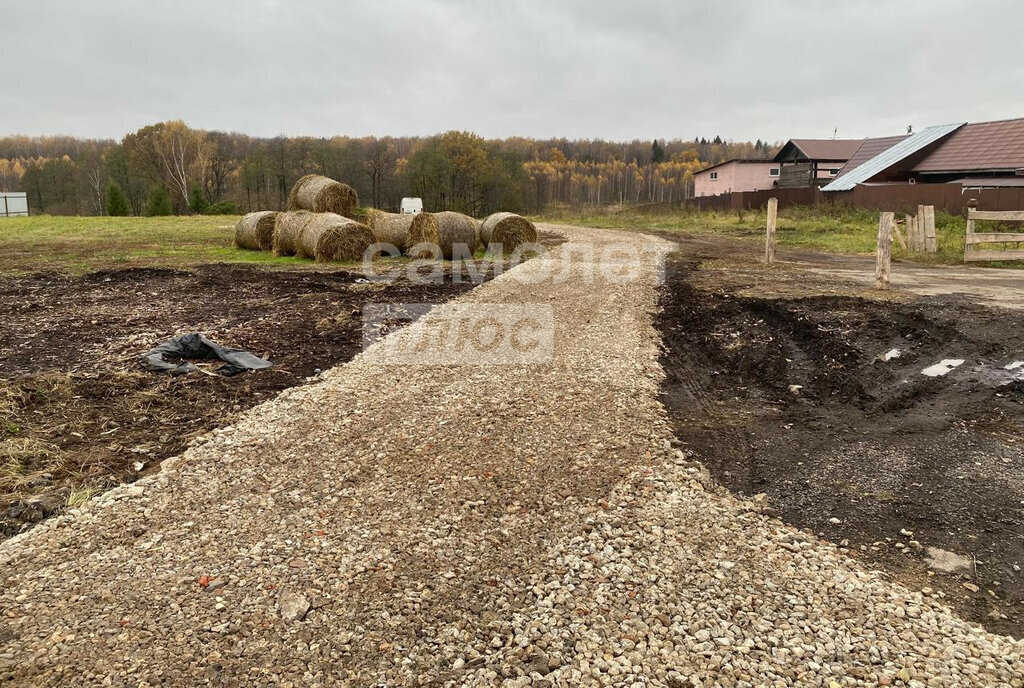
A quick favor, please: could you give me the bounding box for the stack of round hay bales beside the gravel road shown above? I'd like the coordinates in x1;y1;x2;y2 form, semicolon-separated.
234;174;537;262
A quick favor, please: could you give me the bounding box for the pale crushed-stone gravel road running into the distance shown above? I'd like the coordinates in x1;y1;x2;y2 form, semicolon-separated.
0;227;1024;688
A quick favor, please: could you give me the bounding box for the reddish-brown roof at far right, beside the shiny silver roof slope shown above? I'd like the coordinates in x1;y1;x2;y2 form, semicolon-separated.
913;119;1024;173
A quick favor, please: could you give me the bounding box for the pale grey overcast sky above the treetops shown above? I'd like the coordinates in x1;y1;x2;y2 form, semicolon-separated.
8;0;1024;140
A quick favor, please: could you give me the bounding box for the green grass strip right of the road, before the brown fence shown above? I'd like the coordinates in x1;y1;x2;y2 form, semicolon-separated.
534;206;1022;267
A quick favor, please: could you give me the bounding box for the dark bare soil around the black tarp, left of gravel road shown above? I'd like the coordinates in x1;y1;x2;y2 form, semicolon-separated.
0;264;495;536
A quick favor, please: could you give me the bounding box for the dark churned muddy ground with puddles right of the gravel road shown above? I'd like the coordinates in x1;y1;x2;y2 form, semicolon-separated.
659;234;1024;637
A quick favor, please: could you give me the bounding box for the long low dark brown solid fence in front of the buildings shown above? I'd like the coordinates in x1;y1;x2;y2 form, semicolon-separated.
687;183;1024;215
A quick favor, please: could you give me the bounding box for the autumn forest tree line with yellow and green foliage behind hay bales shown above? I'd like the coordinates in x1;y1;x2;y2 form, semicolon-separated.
0;121;777;216
